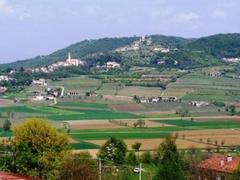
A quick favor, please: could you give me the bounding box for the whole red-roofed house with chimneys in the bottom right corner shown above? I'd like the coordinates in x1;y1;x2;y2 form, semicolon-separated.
197;154;240;180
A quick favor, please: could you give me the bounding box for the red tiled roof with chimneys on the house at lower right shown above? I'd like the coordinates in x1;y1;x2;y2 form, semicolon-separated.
198;154;240;173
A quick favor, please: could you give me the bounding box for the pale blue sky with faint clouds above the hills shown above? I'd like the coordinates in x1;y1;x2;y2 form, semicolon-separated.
0;0;240;63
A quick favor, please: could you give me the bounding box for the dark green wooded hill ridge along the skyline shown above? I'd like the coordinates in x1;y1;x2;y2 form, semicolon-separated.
0;33;240;68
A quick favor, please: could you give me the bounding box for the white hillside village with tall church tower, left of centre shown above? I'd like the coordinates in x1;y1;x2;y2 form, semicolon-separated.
29;53;85;73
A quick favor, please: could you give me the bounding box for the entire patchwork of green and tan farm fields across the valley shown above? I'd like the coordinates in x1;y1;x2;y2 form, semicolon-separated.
0;67;240;155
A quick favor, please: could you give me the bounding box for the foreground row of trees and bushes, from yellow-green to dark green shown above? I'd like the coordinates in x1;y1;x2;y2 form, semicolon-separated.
0;118;238;180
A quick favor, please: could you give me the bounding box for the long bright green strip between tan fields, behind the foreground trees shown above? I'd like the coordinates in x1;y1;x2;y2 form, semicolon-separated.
70;120;240;140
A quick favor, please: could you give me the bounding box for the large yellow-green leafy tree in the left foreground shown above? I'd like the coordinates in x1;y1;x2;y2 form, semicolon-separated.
12;118;69;179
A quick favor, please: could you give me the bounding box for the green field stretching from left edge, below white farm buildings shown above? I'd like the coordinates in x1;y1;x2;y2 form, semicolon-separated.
0;104;139;121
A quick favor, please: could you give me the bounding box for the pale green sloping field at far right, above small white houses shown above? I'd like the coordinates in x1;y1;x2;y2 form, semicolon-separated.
167;74;240;102
